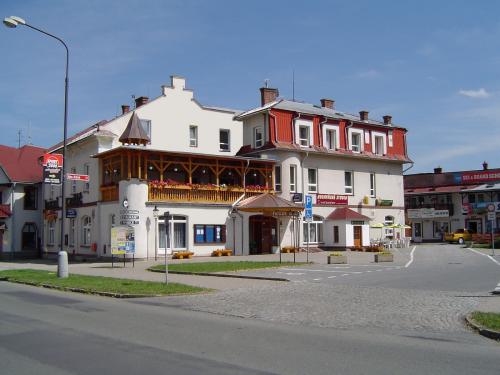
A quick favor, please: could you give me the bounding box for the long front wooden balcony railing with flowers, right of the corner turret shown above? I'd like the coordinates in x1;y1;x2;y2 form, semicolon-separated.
149;183;272;204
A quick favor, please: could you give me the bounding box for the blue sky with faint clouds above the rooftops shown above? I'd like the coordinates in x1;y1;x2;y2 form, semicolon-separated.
0;0;500;173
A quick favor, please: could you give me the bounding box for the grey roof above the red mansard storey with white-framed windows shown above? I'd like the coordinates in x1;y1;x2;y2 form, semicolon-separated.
236;99;399;128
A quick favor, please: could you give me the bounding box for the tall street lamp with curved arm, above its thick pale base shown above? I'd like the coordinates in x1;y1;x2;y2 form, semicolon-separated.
3;16;69;266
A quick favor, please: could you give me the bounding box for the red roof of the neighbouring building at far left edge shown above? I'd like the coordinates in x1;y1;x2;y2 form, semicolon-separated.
0;145;45;182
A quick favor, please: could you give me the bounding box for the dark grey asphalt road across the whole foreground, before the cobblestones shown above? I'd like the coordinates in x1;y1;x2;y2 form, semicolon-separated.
0;282;500;375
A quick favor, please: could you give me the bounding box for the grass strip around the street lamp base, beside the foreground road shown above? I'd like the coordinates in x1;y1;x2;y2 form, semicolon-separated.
0;269;209;296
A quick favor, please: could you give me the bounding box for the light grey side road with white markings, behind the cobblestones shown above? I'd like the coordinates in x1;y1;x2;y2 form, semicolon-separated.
238;244;500;293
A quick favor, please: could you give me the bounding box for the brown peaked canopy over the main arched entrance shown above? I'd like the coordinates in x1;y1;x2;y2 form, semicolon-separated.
236;193;304;216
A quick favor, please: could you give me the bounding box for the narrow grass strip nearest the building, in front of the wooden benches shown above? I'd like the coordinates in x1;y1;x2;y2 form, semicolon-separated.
150;261;306;273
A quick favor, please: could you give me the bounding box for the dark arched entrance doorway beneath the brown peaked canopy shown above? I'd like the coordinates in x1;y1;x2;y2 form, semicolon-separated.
249;215;278;254
